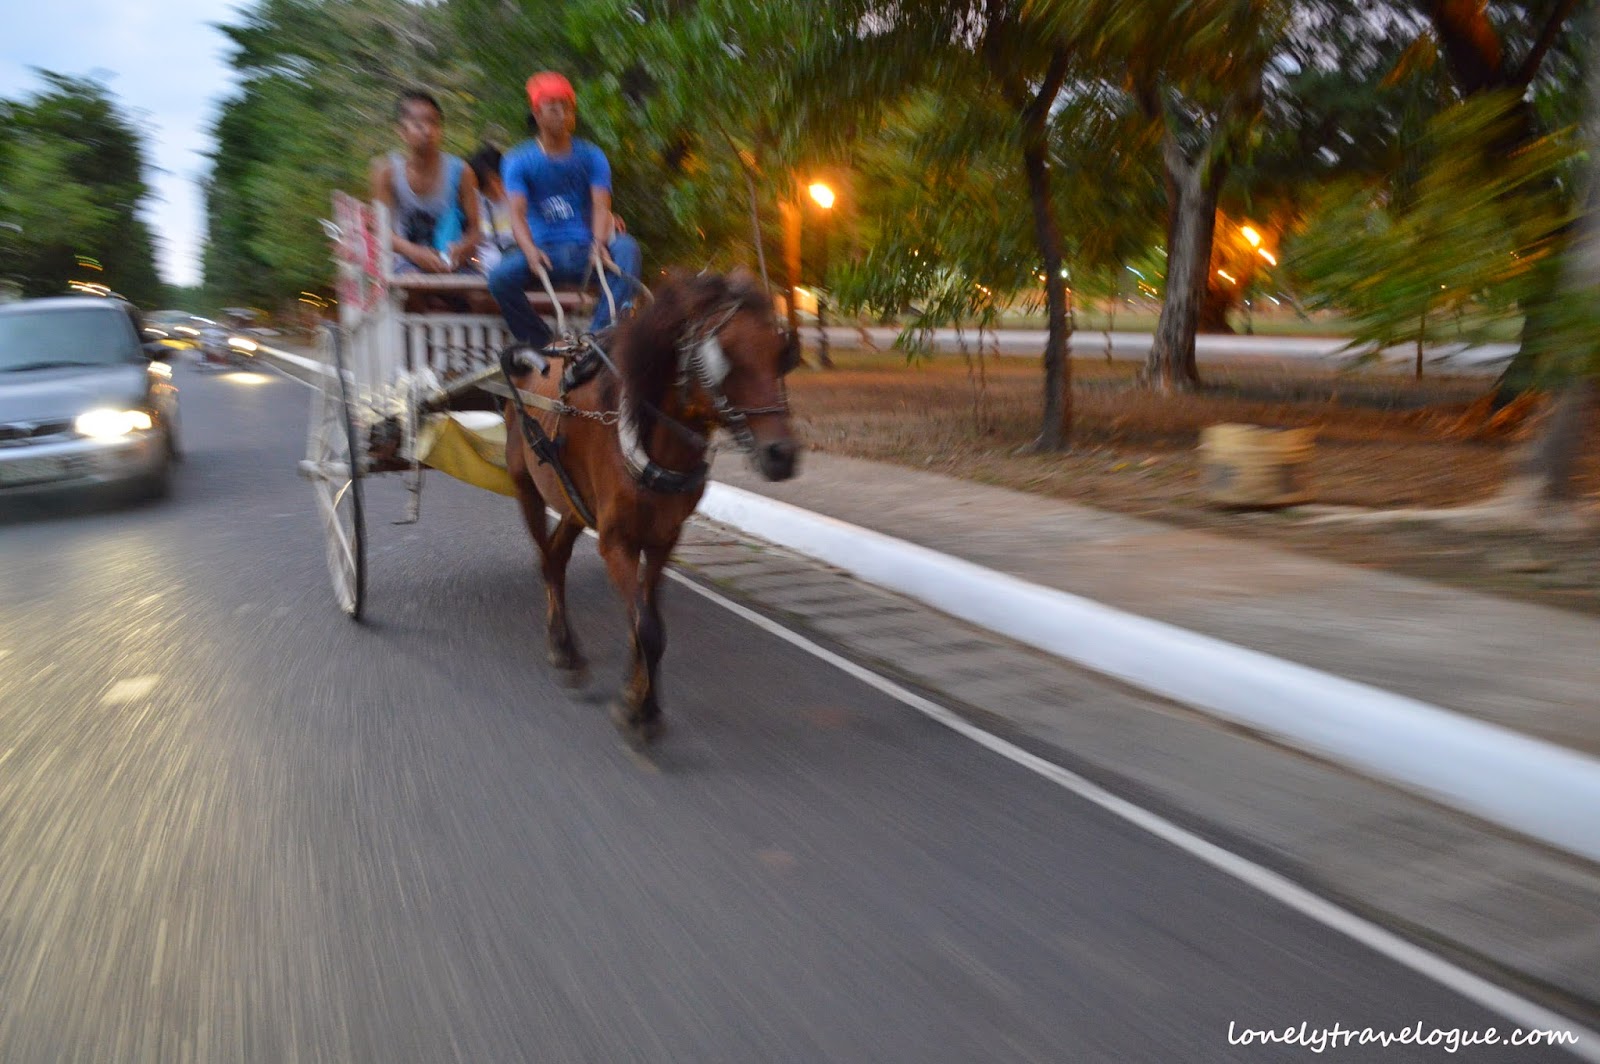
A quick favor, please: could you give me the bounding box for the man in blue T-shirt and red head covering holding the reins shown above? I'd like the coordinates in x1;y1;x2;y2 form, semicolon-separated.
490;72;643;347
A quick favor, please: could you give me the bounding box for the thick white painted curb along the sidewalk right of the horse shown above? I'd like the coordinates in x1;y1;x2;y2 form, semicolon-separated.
699;483;1600;861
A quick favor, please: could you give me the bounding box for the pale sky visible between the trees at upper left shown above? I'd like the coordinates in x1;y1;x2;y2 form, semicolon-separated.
0;0;242;285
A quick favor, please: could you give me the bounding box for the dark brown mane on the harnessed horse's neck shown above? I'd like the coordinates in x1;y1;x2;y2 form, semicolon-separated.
613;270;773;440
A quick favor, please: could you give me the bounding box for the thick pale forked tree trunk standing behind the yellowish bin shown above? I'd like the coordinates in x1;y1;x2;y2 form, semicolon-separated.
1144;134;1222;392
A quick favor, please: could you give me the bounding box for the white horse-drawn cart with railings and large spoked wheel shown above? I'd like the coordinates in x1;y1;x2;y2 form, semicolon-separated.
258;194;613;619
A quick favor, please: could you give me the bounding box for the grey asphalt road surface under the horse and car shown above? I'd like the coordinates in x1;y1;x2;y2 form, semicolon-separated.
0;355;1565;1064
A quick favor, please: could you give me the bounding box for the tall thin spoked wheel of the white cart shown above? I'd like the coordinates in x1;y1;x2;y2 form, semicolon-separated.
310;330;366;621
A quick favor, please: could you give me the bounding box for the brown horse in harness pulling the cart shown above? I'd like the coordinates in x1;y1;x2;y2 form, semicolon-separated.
506;274;798;744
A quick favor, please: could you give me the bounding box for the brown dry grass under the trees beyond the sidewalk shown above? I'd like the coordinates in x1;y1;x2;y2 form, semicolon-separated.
790;352;1600;611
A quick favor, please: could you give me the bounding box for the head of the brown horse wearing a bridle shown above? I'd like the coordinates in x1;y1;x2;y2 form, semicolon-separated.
624;265;800;480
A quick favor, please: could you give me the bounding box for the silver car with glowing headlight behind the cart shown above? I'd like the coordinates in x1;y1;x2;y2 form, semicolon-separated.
0;296;178;507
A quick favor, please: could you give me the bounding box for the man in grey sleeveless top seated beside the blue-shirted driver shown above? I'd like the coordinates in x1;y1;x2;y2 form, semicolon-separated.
370;90;478;274
